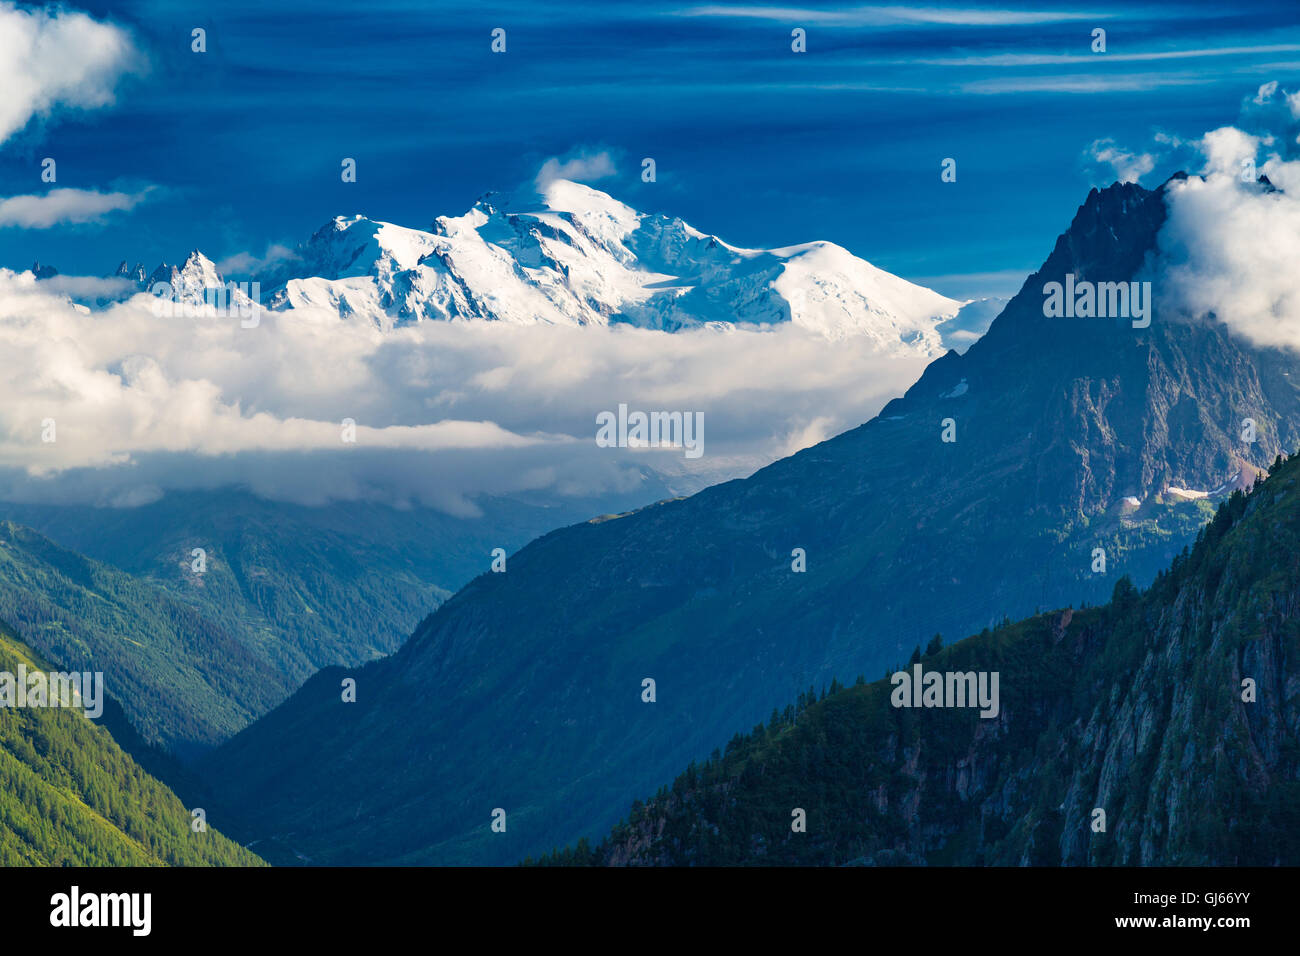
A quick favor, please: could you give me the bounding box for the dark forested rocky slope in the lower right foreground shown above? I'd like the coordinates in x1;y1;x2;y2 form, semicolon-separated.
543;459;1300;865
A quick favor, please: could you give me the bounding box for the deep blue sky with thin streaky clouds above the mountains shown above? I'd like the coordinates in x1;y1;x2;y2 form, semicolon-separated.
0;0;1300;297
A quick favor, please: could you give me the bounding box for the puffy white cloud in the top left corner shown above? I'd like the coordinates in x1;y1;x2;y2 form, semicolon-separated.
0;3;144;143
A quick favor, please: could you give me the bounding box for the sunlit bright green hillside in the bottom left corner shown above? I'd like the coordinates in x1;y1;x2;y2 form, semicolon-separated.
0;626;263;866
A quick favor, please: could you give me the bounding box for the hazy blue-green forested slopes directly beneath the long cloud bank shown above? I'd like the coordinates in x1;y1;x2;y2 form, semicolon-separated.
0;489;670;758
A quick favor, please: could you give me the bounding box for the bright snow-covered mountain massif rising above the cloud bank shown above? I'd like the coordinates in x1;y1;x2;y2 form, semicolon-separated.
263;179;992;355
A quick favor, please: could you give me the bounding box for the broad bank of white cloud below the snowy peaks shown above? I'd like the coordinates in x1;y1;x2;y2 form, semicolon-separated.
0;271;924;515
